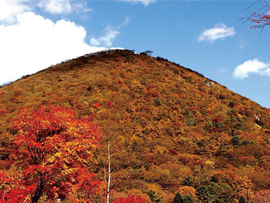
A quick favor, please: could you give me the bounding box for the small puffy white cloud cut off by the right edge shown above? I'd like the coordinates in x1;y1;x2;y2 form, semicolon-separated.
233;59;270;79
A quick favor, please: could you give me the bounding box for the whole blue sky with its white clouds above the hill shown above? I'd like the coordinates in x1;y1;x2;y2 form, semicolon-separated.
0;0;270;108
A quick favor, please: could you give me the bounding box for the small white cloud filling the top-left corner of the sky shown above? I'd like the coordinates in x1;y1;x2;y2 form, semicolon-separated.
0;0;30;23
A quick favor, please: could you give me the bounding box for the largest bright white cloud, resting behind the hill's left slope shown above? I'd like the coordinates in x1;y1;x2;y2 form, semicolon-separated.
0;12;105;84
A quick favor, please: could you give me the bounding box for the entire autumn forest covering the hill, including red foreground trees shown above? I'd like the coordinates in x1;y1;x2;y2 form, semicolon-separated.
0;50;270;203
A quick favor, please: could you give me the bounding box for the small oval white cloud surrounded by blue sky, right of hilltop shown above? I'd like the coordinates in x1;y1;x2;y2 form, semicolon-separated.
198;23;235;42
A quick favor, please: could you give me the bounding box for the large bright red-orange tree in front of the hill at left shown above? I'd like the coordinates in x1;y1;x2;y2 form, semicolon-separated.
6;106;101;202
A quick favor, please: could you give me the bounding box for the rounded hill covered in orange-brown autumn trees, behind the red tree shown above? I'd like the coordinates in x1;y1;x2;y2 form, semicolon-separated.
0;50;270;202
